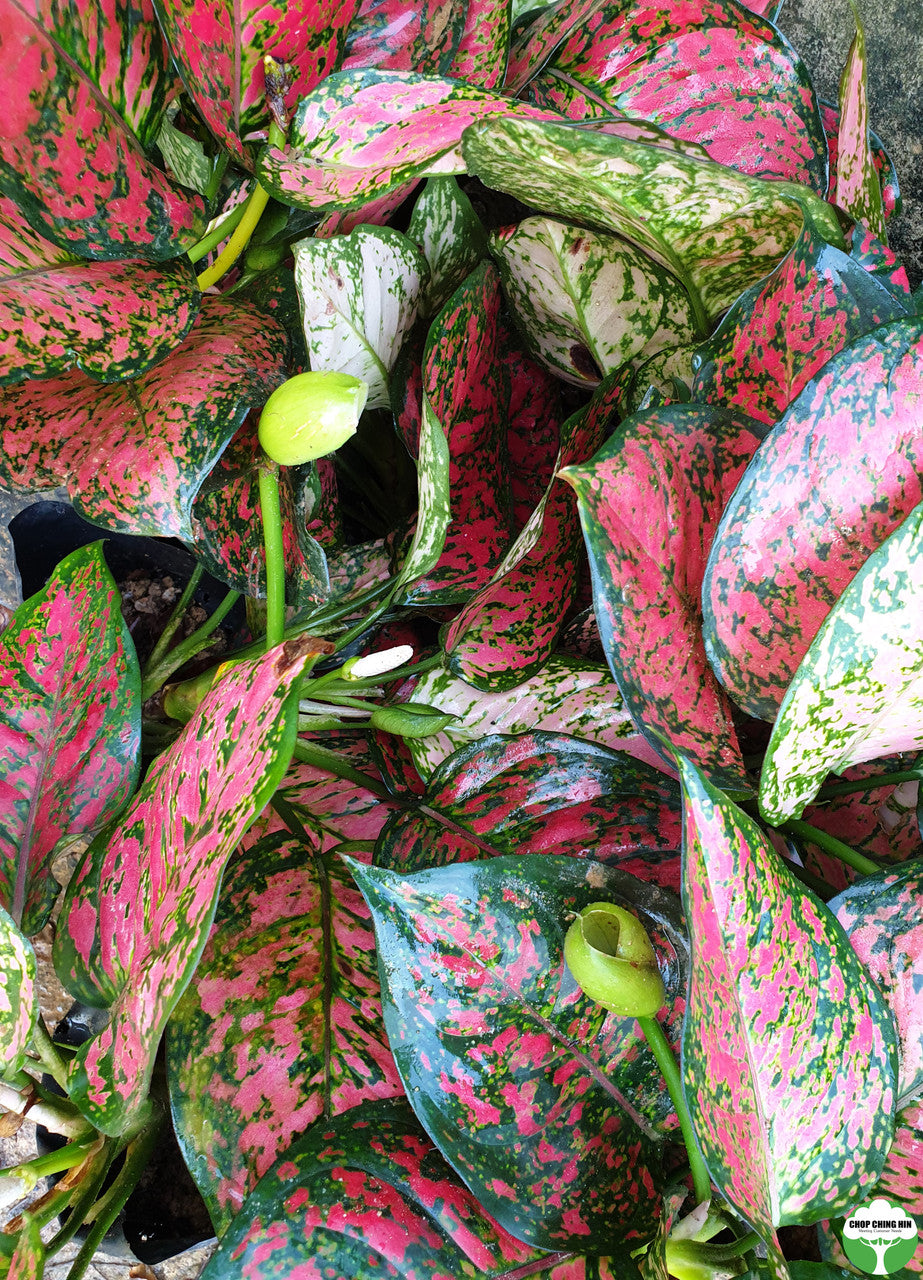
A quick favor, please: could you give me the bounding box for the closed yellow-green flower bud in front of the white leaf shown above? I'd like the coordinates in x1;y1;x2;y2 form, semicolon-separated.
260;372;369;467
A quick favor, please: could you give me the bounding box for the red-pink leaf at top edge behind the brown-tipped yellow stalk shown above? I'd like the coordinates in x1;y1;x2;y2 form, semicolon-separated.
155;0;358;168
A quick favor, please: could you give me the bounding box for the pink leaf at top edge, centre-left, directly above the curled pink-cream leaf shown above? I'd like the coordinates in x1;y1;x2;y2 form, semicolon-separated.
343;0;510;88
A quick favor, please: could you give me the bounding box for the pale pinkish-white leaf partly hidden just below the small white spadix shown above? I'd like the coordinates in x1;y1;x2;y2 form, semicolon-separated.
397;654;659;778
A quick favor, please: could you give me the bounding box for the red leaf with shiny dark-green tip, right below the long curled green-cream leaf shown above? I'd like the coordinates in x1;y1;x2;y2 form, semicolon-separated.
693;218;911;424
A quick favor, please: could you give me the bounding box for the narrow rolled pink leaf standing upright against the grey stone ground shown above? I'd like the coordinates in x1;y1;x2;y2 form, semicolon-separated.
835;16;886;241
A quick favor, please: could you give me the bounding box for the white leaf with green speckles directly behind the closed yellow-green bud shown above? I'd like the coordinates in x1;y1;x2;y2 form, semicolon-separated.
294;227;428;410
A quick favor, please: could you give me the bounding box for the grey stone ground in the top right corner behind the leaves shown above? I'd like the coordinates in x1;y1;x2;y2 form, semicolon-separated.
778;0;923;288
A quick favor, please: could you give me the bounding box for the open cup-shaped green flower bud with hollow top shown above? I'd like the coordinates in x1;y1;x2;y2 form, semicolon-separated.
565;902;666;1018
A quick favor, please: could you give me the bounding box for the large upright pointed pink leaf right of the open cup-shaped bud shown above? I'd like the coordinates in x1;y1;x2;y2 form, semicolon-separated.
678;756;897;1244
